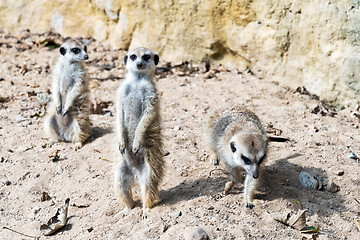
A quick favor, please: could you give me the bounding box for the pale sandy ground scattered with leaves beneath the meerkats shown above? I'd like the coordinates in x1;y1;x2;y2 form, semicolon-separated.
0;32;360;239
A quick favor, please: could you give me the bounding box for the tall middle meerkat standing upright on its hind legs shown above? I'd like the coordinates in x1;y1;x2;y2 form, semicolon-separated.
114;48;165;218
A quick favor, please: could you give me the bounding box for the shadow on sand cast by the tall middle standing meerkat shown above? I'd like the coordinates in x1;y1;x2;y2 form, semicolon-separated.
159;176;229;205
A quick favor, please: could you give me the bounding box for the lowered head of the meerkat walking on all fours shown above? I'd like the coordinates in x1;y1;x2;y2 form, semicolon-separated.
228;133;267;178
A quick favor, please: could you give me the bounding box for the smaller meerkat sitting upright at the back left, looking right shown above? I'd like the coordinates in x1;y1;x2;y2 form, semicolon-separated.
45;38;91;150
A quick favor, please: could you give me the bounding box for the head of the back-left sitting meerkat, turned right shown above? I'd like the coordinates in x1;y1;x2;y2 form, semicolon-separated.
60;38;89;62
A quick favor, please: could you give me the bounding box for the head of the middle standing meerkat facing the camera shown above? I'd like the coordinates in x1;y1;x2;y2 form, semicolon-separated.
124;47;159;73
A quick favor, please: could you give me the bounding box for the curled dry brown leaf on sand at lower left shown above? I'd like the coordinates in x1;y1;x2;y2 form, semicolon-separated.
40;198;70;236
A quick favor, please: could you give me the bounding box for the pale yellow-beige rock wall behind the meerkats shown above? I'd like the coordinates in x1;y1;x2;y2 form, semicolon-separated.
0;0;360;106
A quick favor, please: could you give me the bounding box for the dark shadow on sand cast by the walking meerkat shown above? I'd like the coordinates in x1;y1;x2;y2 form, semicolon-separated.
254;153;347;215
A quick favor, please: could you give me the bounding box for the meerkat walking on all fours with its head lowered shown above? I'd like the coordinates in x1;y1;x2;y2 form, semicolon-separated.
207;106;268;209
